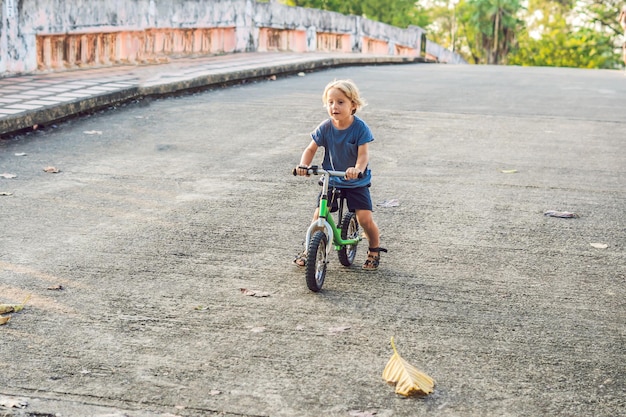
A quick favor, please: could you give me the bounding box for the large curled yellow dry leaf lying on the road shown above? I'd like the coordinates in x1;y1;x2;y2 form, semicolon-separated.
383;337;435;396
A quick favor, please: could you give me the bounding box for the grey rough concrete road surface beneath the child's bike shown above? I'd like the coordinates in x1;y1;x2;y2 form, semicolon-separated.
0;64;626;417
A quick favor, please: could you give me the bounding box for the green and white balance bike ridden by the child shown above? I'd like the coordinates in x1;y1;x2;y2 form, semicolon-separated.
293;165;363;292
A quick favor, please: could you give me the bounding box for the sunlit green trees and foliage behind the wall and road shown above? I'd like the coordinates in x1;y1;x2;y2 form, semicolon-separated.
266;0;625;68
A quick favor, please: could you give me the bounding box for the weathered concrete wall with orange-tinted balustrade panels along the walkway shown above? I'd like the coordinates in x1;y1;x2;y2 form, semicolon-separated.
0;0;462;76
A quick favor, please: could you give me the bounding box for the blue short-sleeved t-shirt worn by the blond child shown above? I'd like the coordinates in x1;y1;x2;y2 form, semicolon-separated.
311;116;374;188
